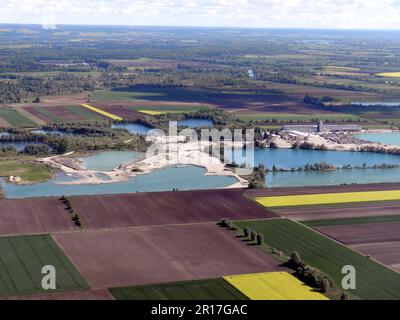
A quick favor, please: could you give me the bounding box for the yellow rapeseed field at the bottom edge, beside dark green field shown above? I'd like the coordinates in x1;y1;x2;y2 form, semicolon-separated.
224;272;329;300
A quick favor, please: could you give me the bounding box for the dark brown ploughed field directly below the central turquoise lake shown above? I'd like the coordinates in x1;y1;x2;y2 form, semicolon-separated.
71;189;277;229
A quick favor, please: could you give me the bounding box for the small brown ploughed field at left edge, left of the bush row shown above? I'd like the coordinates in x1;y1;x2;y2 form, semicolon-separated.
0;198;78;236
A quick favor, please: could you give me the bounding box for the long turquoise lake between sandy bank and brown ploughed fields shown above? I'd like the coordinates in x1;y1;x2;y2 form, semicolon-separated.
0;166;237;198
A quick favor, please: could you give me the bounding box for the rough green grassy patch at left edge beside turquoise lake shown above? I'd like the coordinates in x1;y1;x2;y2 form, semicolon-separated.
0;160;53;183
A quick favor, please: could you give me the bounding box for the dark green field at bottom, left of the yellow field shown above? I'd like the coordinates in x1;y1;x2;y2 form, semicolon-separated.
110;279;247;300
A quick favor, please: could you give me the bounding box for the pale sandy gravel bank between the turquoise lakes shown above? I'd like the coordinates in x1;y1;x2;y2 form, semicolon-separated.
38;138;248;188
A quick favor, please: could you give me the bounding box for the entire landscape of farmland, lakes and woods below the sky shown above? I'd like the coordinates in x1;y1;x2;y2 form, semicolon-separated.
0;16;400;308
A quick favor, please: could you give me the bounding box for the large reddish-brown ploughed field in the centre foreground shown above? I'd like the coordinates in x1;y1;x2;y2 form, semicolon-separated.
54;223;282;288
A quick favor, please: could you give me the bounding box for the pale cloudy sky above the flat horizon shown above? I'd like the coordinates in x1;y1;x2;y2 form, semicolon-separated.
0;0;400;30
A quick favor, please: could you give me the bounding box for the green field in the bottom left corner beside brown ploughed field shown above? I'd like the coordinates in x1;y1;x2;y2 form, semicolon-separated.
0;235;88;296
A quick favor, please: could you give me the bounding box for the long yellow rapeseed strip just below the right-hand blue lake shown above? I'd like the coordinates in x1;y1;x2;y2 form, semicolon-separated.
256;190;400;207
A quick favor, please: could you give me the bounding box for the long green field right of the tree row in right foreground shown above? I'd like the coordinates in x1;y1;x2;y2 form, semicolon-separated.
235;219;400;299
